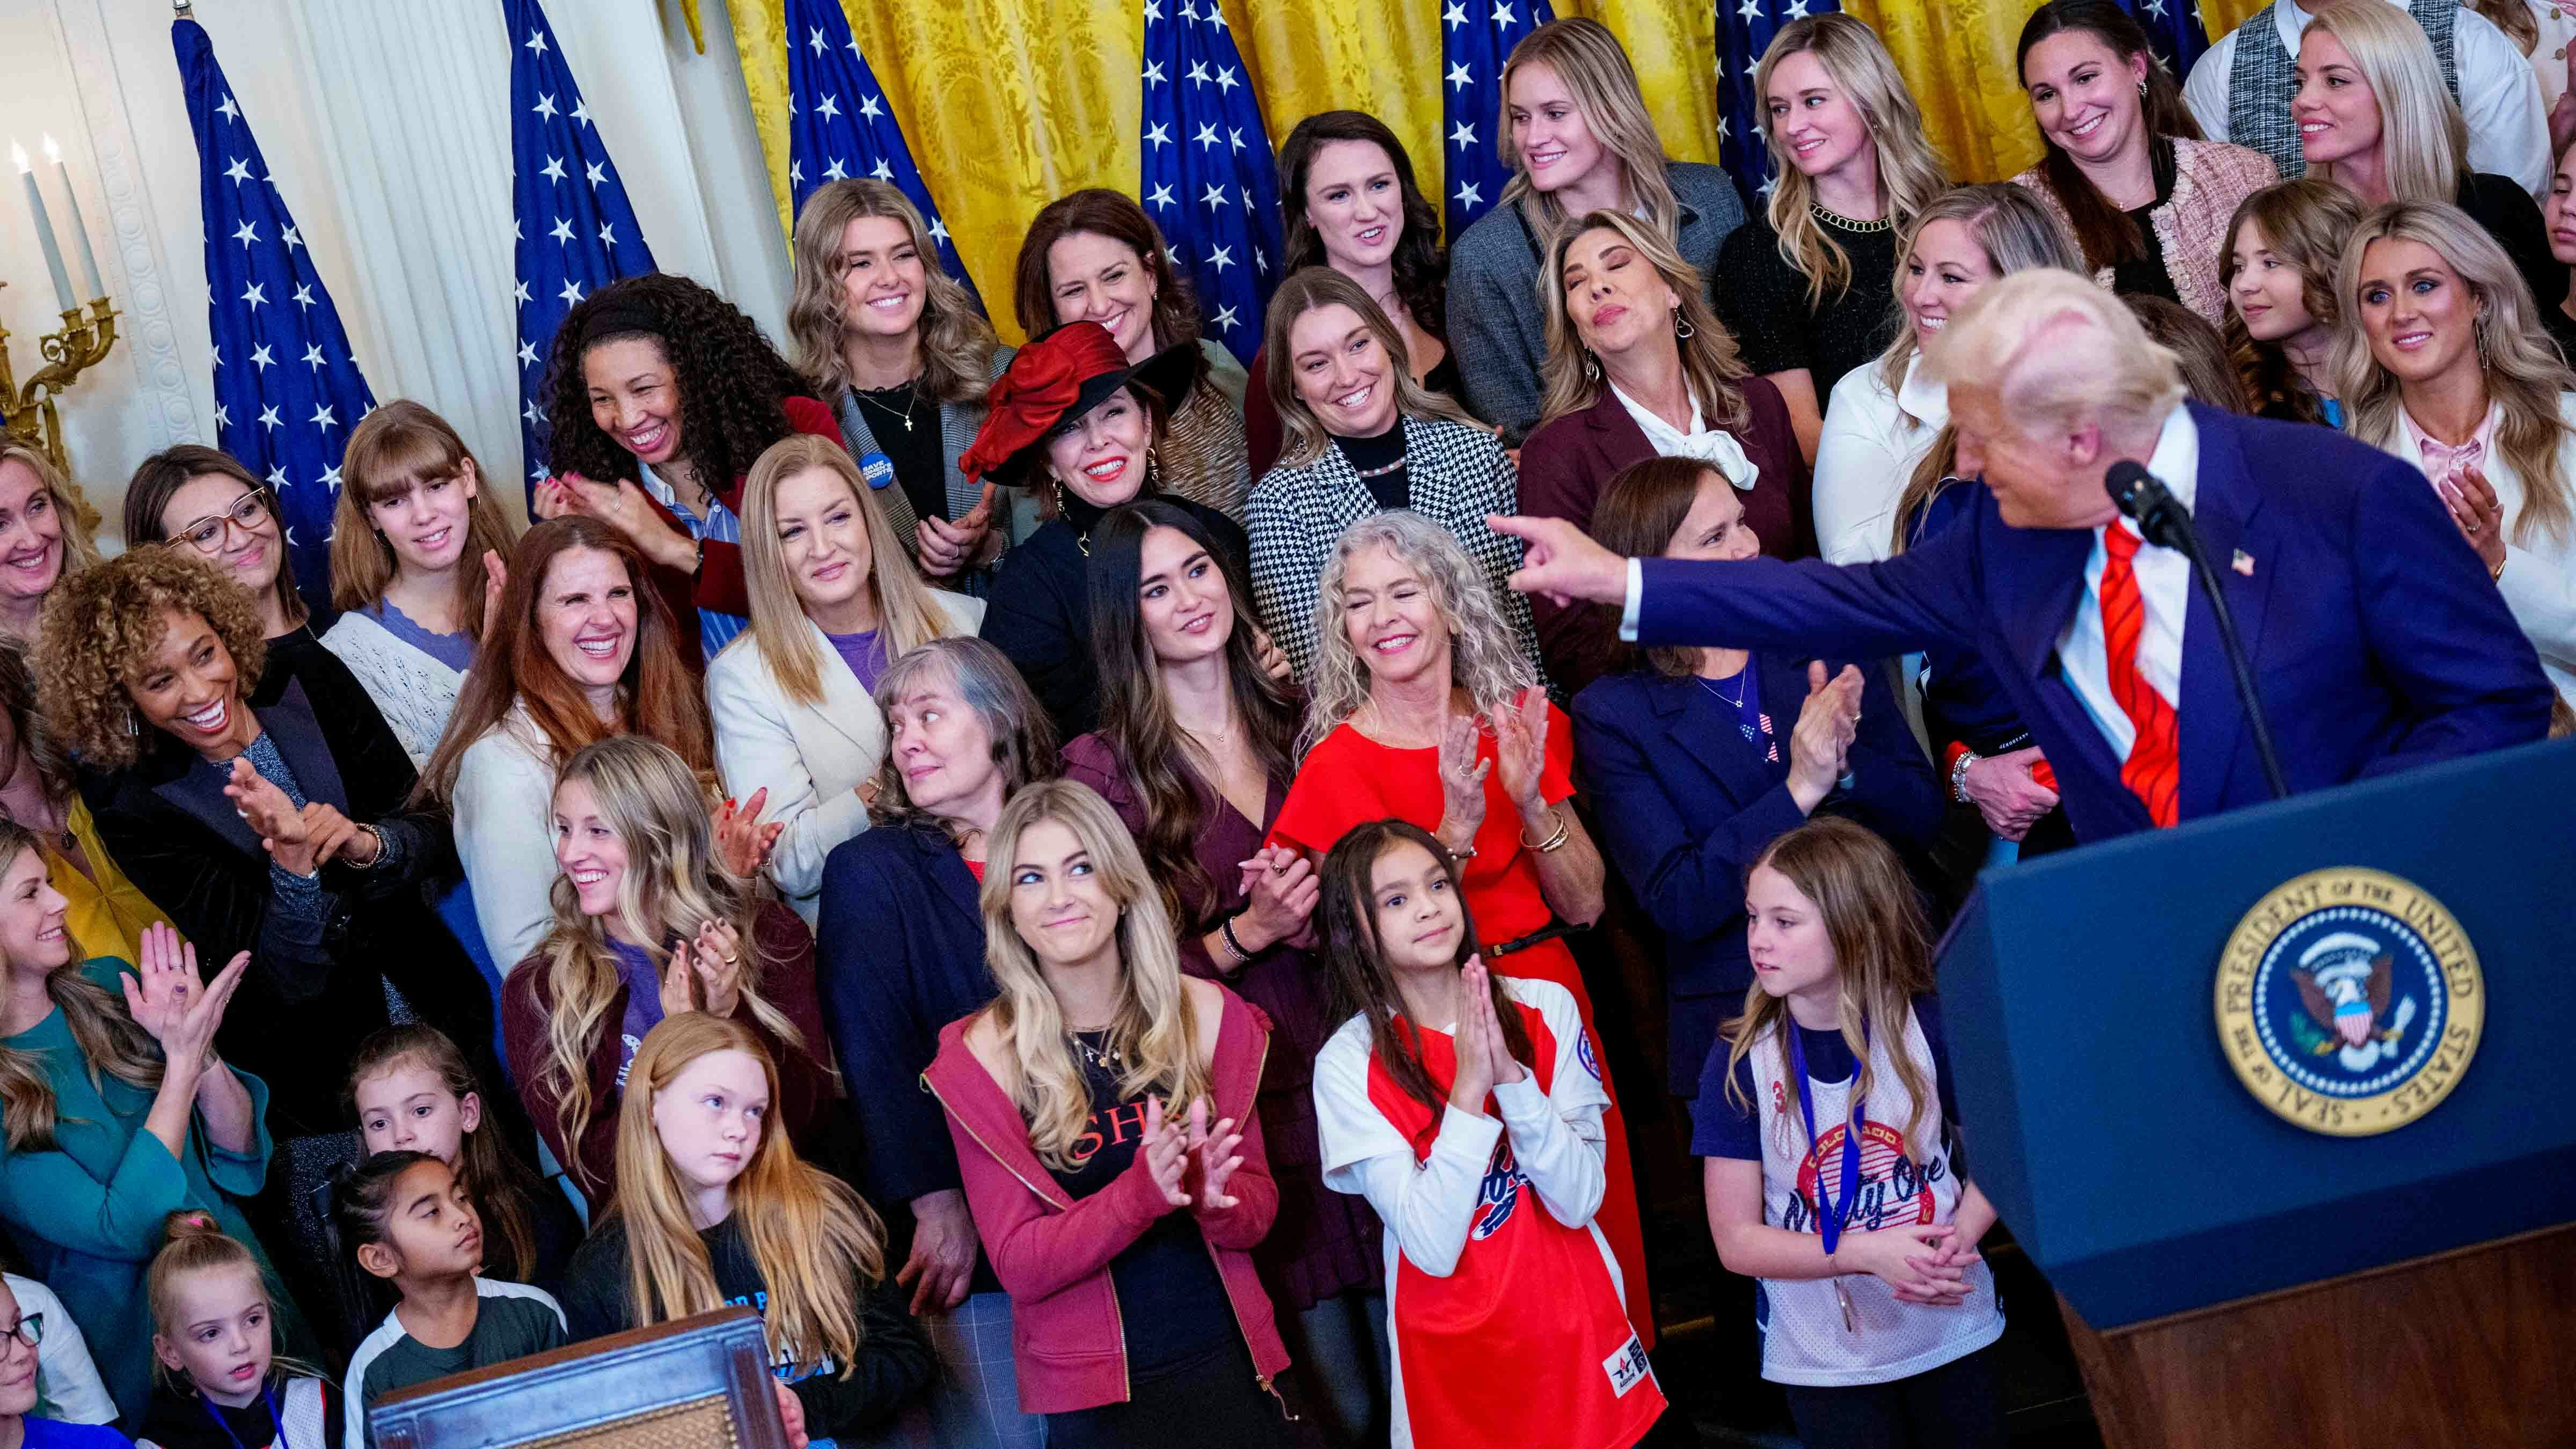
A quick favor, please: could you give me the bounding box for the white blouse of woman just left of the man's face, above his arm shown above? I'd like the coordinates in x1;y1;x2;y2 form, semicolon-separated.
1816;350;1950;565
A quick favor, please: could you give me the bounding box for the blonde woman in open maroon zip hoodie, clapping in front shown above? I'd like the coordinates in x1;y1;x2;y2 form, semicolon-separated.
922;781;1296;1449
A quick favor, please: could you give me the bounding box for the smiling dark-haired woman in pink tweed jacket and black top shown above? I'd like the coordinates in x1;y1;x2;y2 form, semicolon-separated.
2012;0;2277;325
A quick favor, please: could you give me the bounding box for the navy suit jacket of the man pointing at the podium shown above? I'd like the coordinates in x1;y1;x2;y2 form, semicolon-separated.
1638;402;2553;840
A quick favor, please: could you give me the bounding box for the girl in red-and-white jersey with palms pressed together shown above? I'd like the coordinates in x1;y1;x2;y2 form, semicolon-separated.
1314;820;1664;1449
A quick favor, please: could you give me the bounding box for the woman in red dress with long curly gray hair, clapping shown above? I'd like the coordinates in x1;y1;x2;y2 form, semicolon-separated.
1270;508;1654;1346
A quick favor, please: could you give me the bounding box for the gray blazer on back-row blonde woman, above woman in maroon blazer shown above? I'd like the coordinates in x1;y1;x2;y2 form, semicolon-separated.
1448;160;1744;443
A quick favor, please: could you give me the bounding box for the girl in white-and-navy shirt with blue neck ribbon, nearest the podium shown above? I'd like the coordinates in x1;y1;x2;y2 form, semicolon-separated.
1690;820;2004;1446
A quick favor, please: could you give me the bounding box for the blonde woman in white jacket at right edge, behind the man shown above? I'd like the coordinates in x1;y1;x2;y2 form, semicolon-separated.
2334;201;2576;704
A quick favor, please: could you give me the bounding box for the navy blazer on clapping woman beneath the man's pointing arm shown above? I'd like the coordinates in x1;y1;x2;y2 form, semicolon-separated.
1574;655;1945;1099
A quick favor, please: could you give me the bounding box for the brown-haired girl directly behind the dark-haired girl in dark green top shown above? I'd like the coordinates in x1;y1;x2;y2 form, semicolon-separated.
348;1023;582;1292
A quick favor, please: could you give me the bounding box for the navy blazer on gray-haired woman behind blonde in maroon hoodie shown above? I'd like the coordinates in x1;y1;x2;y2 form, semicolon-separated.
814;825;999;1212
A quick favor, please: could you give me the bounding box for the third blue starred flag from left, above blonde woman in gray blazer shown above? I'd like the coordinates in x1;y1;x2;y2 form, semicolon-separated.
786;0;982;304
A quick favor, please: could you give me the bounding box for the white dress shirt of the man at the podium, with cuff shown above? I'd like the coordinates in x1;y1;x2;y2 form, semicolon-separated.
1618;407;2200;760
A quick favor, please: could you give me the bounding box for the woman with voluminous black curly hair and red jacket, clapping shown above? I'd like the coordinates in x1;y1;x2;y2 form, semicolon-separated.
533;273;840;665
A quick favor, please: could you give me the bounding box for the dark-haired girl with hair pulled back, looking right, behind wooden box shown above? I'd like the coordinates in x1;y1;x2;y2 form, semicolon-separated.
332;1153;567;1449
